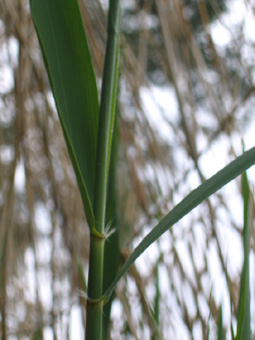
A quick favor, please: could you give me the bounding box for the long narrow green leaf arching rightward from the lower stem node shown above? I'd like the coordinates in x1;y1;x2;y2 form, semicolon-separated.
102;147;255;302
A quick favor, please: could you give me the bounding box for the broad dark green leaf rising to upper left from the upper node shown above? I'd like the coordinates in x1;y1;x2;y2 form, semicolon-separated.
30;0;99;228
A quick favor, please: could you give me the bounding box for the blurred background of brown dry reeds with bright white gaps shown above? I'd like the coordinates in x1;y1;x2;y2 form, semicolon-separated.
0;0;255;340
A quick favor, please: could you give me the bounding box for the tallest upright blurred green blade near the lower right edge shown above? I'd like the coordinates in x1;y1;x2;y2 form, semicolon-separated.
235;172;251;340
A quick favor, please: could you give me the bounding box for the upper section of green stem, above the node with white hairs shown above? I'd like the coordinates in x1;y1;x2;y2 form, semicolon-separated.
94;0;120;233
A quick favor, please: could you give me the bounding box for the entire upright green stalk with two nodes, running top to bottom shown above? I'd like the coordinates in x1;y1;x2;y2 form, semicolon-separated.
86;0;120;340
